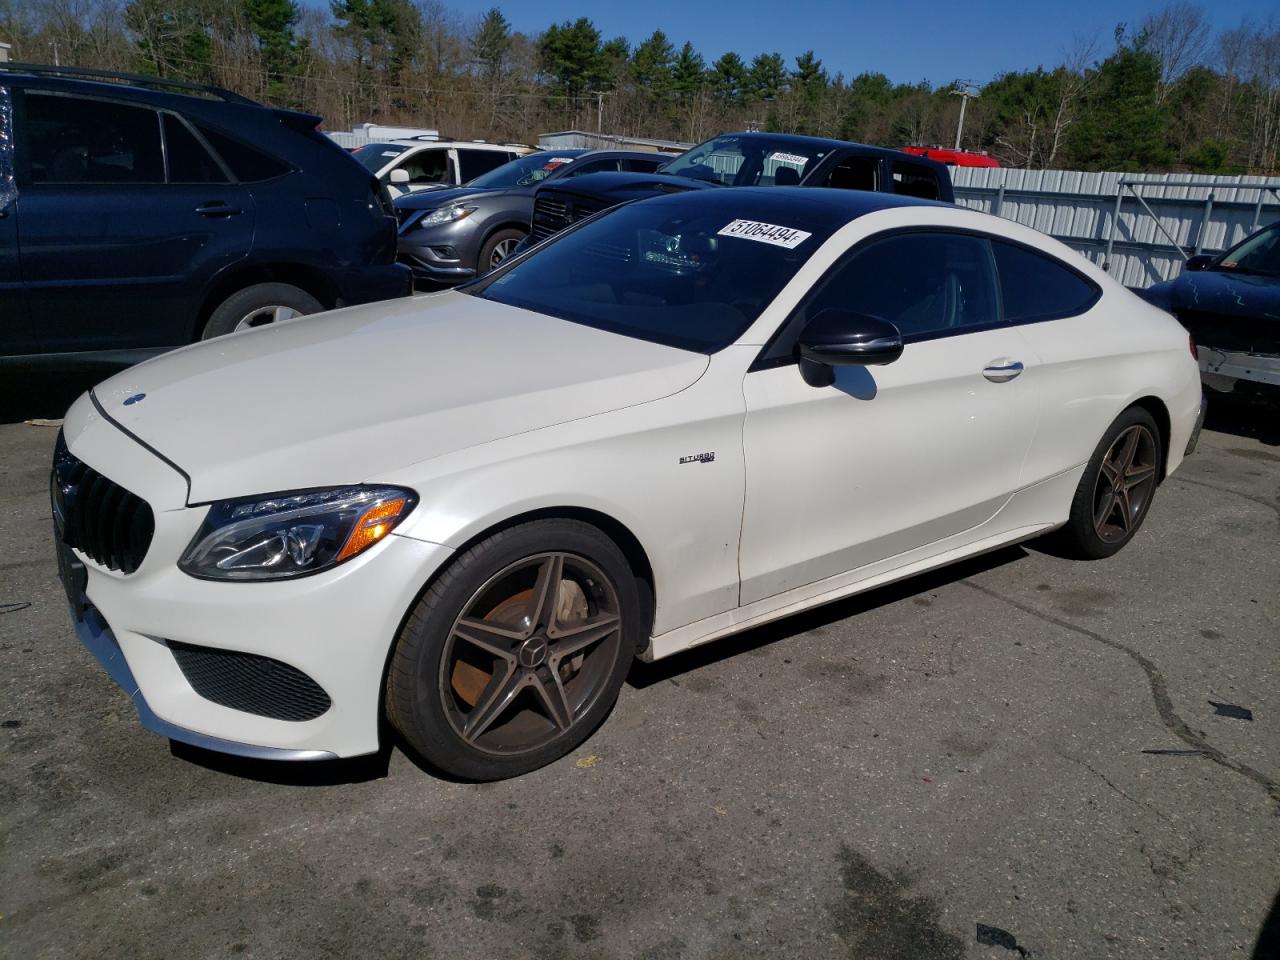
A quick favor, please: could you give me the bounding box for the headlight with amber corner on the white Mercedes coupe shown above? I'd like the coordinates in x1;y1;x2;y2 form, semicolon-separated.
178;486;417;580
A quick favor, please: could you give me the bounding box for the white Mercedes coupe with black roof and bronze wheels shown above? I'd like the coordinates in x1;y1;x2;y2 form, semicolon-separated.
51;188;1203;780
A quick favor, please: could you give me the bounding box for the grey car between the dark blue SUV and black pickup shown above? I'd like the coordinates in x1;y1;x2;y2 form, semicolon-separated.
396;150;669;283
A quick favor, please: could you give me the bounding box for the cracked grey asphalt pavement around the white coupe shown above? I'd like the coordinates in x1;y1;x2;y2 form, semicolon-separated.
0;399;1280;960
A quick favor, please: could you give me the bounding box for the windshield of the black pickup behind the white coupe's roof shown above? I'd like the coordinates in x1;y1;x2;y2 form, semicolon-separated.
662;136;829;187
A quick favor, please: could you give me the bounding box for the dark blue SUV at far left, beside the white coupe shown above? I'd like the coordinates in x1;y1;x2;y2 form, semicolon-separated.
0;64;411;366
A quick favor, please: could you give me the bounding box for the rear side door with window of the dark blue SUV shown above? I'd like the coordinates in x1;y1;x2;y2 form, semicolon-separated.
18;90;253;353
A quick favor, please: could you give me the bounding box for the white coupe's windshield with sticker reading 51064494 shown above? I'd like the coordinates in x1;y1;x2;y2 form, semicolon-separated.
465;191;847;353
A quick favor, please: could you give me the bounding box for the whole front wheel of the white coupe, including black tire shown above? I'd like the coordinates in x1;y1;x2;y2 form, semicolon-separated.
387;520;644;781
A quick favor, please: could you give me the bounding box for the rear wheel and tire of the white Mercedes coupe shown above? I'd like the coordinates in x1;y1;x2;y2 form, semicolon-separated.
1056;407;1165;559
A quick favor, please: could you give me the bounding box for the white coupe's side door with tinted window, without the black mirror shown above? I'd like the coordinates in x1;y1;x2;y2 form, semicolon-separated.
740;233;1037;604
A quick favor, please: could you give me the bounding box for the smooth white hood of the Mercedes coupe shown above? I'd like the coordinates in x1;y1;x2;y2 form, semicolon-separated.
93;292;708;503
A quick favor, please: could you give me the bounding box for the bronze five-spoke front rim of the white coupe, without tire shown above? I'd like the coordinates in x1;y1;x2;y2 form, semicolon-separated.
438;553;622;756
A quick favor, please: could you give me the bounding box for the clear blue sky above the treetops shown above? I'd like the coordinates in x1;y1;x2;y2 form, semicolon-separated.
445;0;1280;84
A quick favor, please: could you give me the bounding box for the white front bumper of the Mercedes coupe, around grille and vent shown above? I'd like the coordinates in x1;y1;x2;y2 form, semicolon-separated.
56;403;451;759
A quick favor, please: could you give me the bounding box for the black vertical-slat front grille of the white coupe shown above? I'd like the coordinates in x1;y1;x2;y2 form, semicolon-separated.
50;433;155;573
